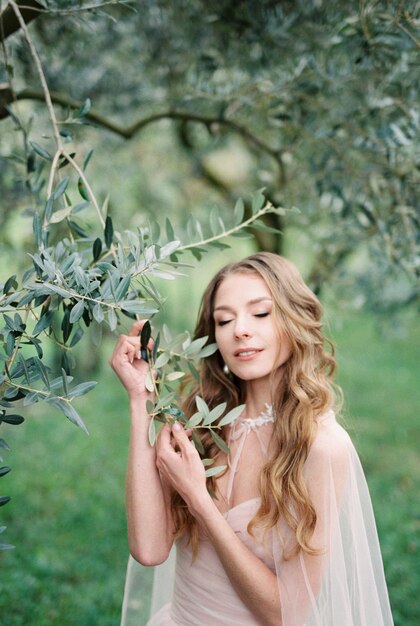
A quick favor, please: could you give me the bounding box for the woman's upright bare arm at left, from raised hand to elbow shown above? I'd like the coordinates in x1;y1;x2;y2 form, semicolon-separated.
110;322;174;565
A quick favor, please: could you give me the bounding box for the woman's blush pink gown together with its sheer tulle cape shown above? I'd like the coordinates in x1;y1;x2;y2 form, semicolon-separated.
121;407;393;626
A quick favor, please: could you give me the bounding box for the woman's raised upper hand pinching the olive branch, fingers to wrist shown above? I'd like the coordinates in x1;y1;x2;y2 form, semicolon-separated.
109;321;153;398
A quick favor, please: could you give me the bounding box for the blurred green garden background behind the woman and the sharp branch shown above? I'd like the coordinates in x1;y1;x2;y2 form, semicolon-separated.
0;0;420;626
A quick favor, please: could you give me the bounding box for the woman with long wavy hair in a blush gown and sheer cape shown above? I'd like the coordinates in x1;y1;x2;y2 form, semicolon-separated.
110;253;393;626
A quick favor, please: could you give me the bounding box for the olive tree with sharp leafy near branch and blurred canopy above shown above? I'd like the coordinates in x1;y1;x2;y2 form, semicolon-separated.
0;0;420;544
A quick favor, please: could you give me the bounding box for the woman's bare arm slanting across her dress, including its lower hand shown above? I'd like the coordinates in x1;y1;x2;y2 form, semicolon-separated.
157;424;281;626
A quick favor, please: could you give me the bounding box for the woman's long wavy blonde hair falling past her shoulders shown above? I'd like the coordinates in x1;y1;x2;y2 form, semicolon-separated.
172;252;340;555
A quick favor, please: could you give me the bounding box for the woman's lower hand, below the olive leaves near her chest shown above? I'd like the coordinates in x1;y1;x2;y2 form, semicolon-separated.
156;422;209;513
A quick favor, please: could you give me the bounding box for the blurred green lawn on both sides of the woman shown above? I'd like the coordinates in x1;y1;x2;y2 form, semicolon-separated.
0;315;420;626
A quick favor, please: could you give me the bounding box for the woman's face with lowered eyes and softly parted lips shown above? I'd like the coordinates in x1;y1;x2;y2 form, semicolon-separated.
213;273;291;381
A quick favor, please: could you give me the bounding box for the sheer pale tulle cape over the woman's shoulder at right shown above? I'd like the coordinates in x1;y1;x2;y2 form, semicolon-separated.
273;411;393;626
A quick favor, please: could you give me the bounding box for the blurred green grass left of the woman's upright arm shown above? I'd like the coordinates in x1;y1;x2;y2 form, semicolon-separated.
0;371;151;626
